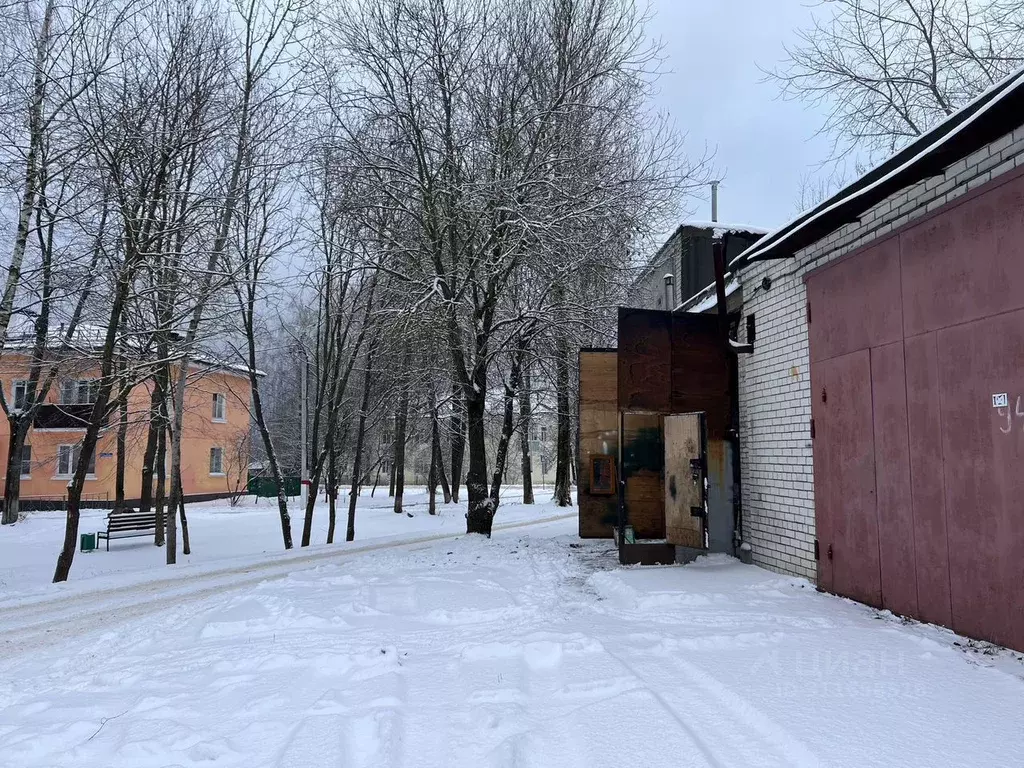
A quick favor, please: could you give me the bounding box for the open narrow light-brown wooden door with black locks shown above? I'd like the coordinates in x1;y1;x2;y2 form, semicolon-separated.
665;414;705;549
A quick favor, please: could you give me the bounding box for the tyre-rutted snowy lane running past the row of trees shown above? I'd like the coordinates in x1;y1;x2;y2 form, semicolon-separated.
0;512;575;656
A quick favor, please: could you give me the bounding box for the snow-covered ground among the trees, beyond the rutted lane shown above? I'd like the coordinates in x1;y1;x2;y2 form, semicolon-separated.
0;486;565;603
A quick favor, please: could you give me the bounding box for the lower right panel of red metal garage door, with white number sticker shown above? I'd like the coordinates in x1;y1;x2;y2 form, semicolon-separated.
937;311;1024;647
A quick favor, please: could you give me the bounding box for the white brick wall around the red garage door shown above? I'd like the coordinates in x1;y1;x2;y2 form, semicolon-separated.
739;127;1024;580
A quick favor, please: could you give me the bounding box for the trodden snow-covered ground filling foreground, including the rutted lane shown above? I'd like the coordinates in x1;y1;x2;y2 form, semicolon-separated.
0;495;1024;768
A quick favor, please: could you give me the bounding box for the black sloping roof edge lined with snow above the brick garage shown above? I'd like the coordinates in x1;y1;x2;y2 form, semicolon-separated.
730;69;1024;268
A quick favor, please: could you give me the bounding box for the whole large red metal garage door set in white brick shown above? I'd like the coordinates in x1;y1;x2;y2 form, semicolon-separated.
807;165;1024;649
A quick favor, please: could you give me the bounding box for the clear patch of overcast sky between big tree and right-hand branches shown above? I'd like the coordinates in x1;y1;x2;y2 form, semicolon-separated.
650;0;830;229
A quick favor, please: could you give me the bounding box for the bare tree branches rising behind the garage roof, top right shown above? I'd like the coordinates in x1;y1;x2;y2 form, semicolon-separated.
767;0;1024;157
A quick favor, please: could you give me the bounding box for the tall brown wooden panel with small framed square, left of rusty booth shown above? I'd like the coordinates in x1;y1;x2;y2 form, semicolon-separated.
577;349;618;539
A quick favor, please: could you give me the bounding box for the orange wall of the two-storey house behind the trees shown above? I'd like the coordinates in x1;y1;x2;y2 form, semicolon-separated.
0;353;250;501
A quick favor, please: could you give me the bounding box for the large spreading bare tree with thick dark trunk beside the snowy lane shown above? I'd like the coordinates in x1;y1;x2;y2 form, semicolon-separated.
332;0;691;535
